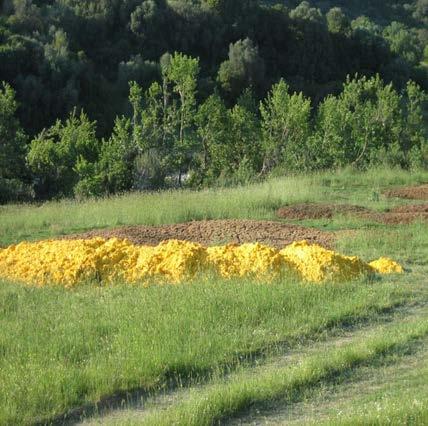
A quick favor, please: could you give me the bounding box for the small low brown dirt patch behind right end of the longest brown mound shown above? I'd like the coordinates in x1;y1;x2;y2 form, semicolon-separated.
277;203;371;220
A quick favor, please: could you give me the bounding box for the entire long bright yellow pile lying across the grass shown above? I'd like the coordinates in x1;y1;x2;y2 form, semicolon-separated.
0;238;403;287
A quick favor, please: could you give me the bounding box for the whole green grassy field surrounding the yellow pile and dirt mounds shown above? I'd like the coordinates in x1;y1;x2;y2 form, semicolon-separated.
0;170;428;425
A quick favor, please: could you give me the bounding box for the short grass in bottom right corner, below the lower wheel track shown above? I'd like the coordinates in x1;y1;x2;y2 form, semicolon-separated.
304;350;428;426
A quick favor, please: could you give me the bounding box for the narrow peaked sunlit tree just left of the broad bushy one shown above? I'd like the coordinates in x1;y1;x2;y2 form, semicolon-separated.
260;79;311;173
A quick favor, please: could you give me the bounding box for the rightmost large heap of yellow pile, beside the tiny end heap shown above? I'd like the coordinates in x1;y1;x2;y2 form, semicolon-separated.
280;241;373;282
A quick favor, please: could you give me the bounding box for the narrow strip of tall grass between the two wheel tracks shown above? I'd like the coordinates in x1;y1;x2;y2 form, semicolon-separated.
139;316;428;426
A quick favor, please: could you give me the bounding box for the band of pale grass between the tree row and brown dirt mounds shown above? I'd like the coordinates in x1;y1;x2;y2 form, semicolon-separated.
0;169;428;246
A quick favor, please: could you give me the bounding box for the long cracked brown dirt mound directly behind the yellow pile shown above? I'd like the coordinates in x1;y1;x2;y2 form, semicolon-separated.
64;220;334;248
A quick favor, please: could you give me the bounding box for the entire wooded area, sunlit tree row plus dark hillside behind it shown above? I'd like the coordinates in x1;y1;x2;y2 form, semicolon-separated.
0;0;428;202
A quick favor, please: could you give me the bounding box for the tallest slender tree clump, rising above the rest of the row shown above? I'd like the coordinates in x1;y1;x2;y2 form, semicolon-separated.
126;53;199;185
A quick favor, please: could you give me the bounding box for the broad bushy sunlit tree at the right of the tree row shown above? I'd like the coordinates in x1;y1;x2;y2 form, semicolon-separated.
313;76;403;168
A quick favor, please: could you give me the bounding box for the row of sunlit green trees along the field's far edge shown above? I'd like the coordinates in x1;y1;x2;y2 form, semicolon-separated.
0;53;428;202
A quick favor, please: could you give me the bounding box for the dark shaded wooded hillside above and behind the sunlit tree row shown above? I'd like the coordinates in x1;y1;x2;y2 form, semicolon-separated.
0;0;428;138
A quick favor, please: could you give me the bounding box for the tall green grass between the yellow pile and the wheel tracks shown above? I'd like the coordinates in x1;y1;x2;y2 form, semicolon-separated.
0;274;413;424
